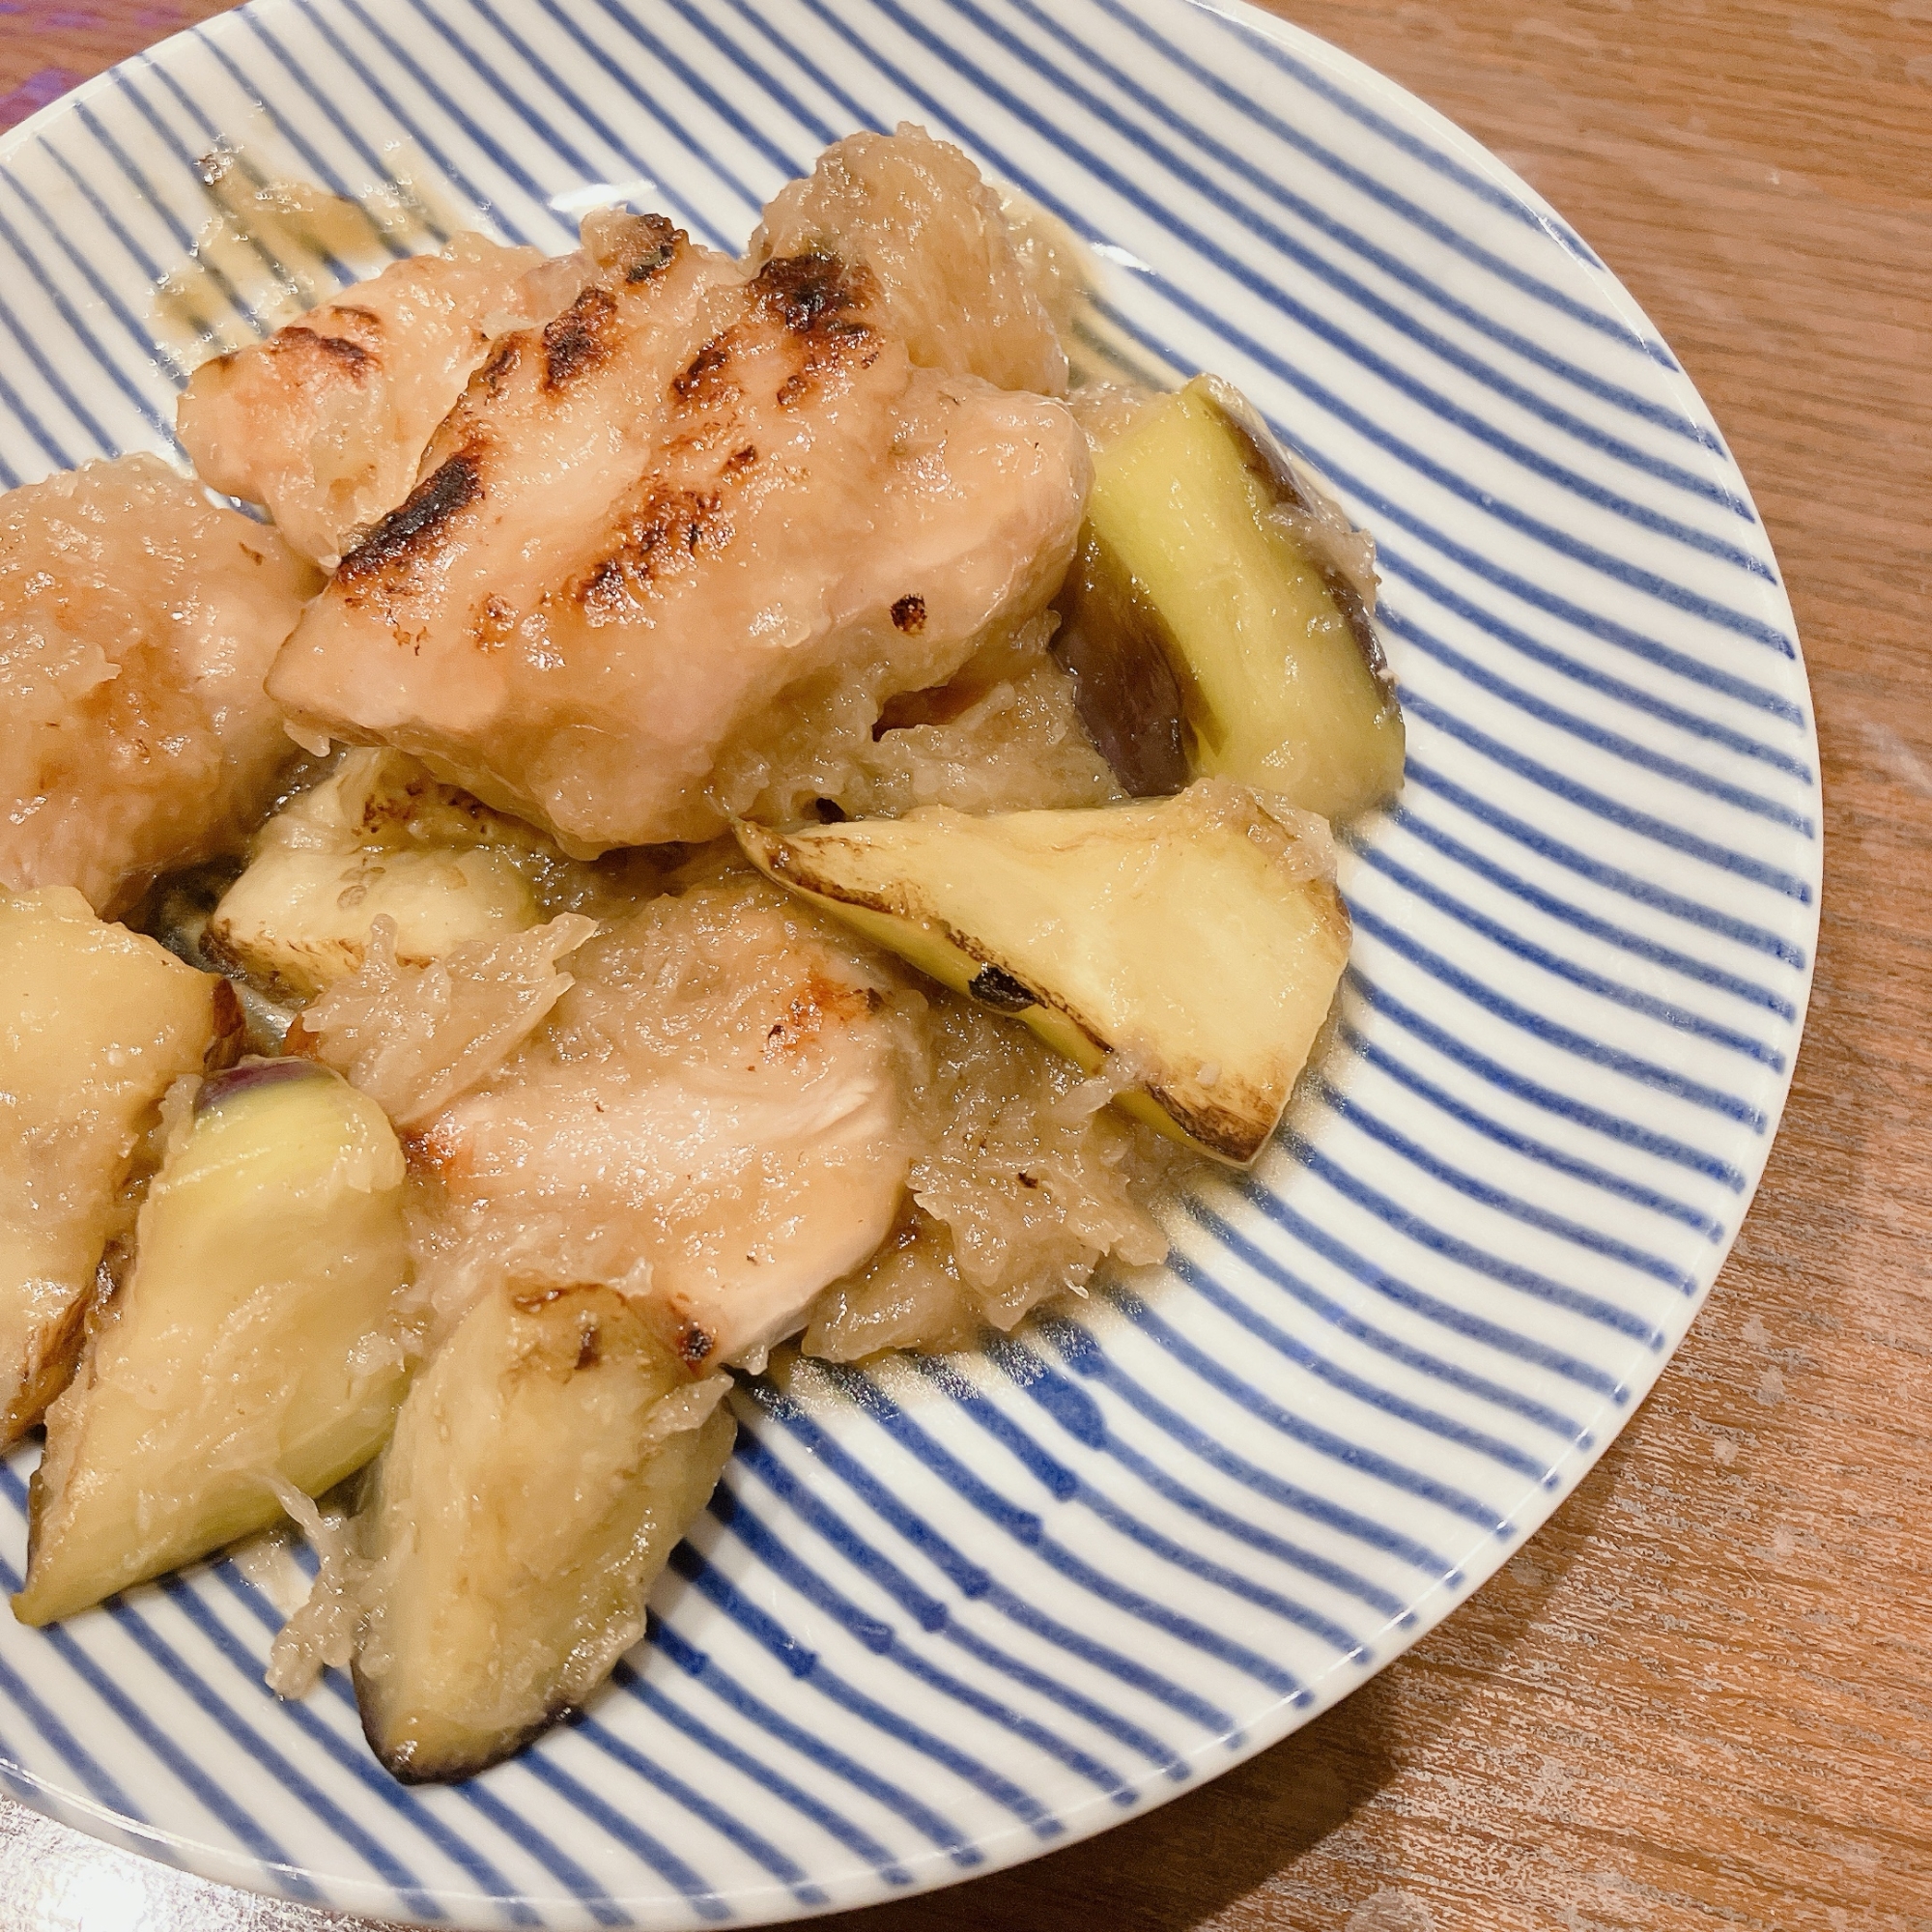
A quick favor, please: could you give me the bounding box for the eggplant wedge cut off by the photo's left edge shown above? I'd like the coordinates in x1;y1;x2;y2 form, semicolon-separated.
0;887;240;1447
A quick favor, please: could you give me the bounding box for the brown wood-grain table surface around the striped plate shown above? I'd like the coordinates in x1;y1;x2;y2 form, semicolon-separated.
0;0;1932;1932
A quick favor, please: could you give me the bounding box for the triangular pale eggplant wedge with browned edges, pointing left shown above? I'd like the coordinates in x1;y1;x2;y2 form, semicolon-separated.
738;779;1349;1165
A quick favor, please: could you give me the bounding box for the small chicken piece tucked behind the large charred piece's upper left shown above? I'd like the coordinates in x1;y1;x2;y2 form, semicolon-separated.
176;234;583;568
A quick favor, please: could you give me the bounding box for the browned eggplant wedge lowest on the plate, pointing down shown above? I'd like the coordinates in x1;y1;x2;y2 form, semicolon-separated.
355;1287;734;1783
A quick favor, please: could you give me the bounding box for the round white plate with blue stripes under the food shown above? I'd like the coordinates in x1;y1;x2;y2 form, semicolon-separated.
0;0;1820;1928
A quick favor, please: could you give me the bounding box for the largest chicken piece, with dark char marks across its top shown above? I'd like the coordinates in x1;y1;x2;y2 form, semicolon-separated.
270;214;1088;856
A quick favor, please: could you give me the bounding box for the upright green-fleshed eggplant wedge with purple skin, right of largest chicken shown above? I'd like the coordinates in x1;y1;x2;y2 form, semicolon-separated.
1053;377;1403;819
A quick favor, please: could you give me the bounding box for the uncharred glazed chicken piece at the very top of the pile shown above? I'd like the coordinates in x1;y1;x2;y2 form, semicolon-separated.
748;122;1066;396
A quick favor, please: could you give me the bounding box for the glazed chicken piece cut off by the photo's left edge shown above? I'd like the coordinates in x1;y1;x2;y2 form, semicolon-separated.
0;456;321;914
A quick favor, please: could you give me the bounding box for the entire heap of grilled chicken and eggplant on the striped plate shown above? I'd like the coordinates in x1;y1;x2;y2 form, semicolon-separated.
0;126;1403;1781
